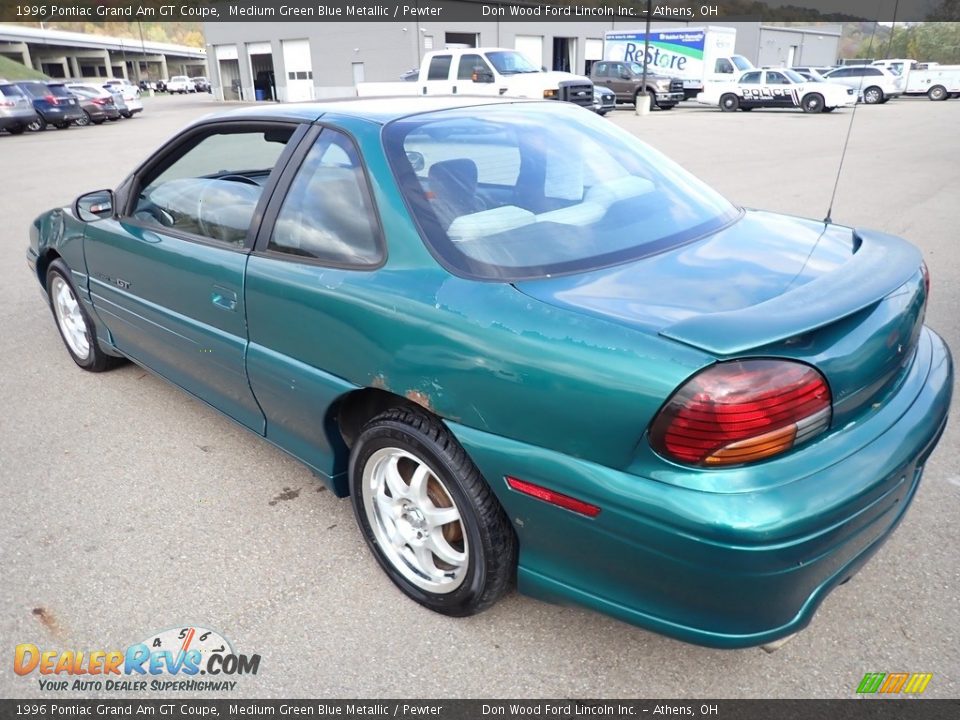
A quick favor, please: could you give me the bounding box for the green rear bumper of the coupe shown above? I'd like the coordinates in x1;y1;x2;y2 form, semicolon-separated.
451;329;953;648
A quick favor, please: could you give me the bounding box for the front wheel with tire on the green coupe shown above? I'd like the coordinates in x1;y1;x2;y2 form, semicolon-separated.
47;259;121;372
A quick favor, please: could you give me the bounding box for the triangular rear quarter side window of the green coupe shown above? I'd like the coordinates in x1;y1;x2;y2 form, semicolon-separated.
267;128;382;267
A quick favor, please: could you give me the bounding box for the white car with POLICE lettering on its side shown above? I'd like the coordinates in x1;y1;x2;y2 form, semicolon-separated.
697;68;857;113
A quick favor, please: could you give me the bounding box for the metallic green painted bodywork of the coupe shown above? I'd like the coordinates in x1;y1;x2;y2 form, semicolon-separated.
28;100;953;647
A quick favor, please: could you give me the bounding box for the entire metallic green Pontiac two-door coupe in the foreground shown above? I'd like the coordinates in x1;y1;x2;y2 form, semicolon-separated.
28;98;953;647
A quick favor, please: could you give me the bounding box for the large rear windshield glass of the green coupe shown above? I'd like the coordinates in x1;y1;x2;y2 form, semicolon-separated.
384;103;739;281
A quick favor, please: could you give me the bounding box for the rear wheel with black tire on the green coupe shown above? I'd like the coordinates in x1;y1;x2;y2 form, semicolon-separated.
350;408;517;617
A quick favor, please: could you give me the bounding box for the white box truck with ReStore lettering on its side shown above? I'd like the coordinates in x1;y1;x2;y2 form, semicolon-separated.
603;25;753;99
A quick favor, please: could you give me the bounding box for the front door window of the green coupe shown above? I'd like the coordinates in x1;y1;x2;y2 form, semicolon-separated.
131;126;294;247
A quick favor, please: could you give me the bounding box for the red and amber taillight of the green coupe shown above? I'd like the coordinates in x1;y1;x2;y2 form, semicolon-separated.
650;360;831;467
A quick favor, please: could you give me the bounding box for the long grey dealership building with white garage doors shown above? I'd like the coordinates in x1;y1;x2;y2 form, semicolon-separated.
204;11;841;102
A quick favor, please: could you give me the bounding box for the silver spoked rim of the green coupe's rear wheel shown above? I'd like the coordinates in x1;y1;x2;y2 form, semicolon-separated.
362;448;469;594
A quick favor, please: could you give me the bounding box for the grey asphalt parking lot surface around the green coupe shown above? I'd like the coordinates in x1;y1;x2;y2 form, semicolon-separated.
0;96;960;698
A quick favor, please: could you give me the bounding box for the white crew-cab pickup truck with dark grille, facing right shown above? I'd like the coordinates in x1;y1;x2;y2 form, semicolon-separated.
357;48;593;107
